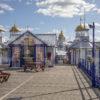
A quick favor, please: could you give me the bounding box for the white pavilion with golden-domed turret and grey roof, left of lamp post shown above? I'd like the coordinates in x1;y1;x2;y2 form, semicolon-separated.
70;24;91;65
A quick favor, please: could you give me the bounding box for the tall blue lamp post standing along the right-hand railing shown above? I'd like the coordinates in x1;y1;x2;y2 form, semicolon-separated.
89;22;96;87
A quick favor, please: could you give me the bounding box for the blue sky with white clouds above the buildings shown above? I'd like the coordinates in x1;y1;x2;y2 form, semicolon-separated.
0;0;100;40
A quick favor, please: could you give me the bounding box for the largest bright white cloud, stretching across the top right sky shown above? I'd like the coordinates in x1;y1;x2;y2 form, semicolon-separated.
36;0;99;17
